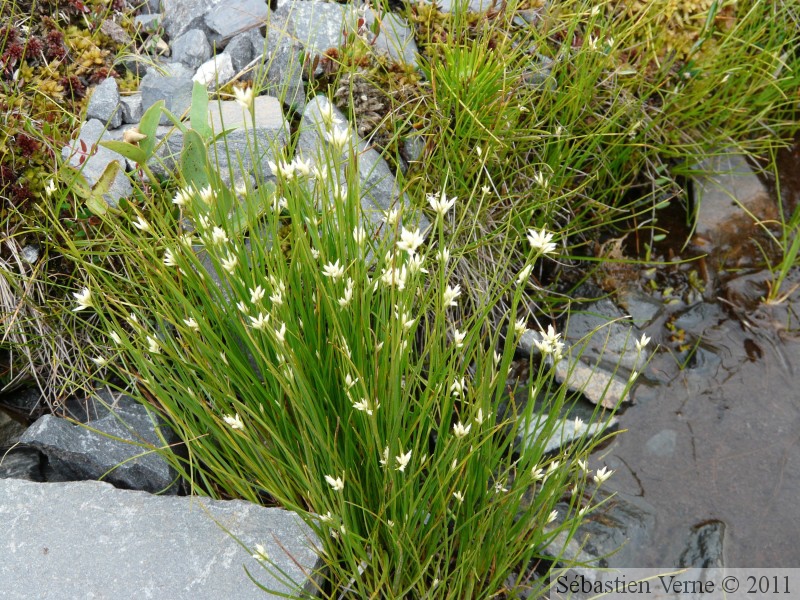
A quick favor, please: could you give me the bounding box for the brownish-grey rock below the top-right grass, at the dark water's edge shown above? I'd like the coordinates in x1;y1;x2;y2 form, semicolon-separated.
692;150;775;240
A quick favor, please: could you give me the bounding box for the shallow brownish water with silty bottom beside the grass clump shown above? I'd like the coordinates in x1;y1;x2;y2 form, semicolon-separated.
595;144;800;567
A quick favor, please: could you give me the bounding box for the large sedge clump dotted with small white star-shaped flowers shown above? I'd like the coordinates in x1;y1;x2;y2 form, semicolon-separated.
50;92;624;598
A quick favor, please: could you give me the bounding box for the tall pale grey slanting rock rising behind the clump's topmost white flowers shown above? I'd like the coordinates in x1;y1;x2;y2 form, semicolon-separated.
297;96;430;235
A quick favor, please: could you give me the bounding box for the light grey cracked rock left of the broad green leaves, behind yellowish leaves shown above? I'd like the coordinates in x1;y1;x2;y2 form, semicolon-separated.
61;119;133;207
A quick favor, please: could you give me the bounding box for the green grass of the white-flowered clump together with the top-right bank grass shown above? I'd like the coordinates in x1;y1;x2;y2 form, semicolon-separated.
1;0;800;598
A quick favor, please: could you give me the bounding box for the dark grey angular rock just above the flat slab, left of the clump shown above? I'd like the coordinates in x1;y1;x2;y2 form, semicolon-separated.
21;391;177;494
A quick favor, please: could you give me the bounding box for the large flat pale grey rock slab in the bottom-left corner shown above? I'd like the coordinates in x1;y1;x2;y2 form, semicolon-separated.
0;479;319;600
